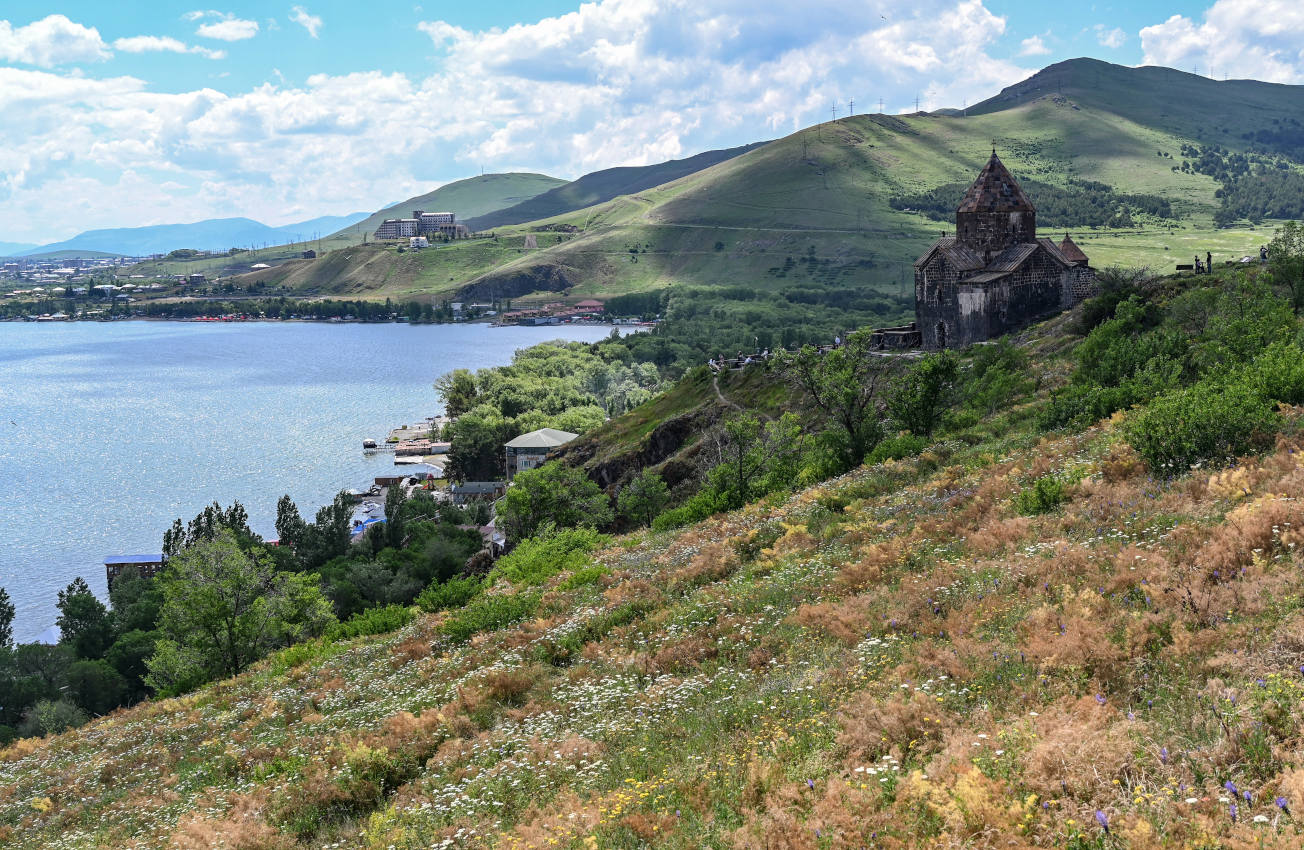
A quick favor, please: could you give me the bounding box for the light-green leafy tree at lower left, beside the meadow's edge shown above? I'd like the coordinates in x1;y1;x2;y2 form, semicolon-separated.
146;531;334;694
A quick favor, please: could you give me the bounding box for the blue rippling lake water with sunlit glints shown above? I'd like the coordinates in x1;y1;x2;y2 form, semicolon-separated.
0;322;612;640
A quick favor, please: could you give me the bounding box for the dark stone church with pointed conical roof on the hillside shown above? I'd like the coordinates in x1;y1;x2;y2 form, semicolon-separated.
911;150;1095;348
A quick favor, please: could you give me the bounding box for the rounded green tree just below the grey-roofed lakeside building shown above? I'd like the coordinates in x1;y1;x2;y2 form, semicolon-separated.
498;460;612;541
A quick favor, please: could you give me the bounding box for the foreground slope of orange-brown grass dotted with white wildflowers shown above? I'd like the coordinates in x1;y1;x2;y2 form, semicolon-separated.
12;396;1304;850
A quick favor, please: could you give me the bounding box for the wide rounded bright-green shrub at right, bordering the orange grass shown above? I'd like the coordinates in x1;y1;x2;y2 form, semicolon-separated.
1125;381;1278;476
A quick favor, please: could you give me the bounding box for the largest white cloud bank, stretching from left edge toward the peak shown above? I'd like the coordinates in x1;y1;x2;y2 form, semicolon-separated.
0;0;1030;241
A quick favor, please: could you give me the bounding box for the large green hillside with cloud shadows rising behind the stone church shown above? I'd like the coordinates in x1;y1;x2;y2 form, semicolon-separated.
242;60;1304;307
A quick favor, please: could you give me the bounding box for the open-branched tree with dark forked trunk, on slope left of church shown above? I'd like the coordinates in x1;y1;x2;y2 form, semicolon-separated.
784;330;896;469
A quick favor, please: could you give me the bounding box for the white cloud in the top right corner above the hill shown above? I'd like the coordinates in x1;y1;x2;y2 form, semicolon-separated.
1141;0;1304;83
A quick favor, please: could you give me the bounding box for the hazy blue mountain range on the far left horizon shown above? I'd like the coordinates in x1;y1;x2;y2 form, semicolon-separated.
11;213;369;257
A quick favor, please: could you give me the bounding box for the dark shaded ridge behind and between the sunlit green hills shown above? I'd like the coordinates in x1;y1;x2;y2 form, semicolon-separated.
467;142;765;231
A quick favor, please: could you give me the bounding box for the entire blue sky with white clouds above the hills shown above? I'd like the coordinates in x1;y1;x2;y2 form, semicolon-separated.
0;0;1304;242
